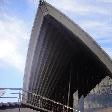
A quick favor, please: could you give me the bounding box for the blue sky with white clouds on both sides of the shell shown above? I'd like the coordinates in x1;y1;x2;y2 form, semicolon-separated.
0;0;112;101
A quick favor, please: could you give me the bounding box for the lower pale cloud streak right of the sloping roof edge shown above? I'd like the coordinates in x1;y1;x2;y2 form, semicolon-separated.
80;20;112;39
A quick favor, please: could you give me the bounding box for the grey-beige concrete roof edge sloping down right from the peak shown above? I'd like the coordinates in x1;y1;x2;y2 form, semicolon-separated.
39;1;112;75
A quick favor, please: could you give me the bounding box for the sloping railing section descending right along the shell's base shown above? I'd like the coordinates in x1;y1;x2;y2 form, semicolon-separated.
23;91;75;112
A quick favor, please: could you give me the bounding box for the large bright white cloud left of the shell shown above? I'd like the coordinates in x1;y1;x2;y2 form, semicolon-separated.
0;14;29;72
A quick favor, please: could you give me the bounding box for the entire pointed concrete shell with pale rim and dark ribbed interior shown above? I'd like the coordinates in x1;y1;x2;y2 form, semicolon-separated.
23;2;112;110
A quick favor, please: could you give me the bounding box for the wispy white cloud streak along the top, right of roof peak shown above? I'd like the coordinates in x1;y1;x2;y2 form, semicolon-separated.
47;0;111;15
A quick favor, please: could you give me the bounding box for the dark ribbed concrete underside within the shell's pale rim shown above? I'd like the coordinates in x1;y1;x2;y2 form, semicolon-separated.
26;16;109;105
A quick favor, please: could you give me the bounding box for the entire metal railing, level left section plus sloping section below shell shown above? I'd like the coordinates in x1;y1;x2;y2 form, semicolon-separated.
0;88;80;112
